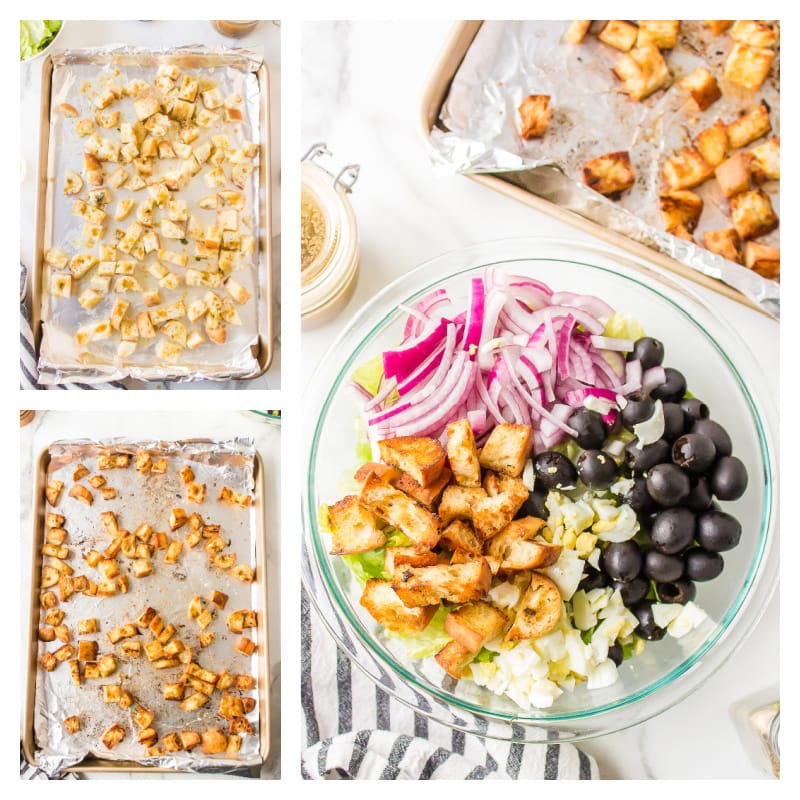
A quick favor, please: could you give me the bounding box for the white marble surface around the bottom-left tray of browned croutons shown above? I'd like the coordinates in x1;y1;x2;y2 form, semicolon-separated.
20;411;281;780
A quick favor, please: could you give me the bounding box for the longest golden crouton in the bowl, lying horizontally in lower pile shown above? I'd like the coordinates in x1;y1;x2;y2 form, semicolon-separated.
392;558;492;608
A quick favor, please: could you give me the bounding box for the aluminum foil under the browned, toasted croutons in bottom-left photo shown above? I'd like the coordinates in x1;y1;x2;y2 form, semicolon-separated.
34;439;266;775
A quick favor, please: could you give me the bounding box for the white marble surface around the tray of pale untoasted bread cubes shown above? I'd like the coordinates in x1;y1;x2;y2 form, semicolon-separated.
20;20;281;389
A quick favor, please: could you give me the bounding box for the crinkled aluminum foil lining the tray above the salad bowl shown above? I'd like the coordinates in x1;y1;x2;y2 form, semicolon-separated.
428;21;780;318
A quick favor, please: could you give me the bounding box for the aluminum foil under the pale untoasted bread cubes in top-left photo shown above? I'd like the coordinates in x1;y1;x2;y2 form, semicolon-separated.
39;46;266;384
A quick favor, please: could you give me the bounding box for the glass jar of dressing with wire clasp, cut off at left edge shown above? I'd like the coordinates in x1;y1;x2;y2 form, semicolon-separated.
300;144;359;323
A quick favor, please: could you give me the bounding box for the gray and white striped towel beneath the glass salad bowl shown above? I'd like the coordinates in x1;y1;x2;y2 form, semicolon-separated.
301;589;599;780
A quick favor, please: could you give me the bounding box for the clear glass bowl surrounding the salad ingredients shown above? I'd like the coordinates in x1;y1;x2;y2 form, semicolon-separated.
302;238;778;742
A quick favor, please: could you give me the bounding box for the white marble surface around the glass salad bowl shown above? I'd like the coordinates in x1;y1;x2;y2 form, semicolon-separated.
301;22;779;779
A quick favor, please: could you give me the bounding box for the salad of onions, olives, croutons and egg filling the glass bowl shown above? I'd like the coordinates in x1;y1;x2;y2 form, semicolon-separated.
321;268;747;710
